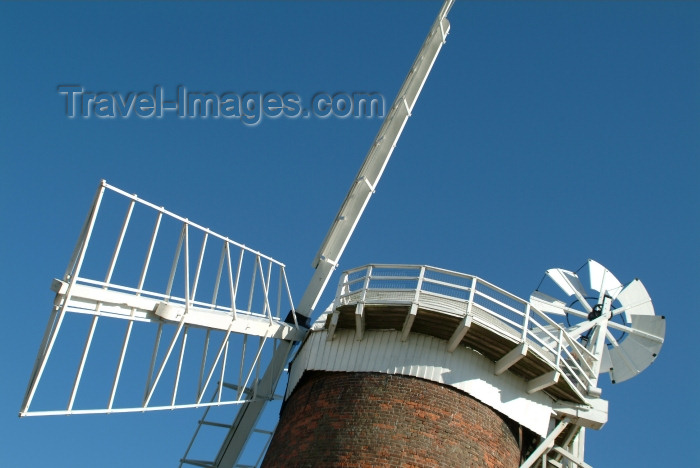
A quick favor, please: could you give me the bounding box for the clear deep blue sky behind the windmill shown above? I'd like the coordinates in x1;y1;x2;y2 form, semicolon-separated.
0;1;700;467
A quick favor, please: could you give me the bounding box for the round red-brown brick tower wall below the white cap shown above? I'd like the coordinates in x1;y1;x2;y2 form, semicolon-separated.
263;371;532;468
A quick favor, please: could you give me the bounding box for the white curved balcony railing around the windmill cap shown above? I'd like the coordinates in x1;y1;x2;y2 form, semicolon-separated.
334;265;596;396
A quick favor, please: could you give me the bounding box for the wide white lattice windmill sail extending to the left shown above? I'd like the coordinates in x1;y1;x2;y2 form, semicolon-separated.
20;181;306;416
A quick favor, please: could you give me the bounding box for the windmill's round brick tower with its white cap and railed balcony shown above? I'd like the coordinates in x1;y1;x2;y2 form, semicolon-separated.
263;265;592;468
